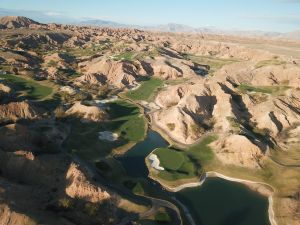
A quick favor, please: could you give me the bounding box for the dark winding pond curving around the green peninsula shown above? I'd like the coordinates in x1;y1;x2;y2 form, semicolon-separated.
118;130;270;225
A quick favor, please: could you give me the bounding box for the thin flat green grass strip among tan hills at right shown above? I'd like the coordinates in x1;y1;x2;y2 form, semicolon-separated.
238;84;289;94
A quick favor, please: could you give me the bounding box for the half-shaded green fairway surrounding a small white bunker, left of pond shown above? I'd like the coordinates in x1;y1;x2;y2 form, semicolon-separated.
66;100;146;161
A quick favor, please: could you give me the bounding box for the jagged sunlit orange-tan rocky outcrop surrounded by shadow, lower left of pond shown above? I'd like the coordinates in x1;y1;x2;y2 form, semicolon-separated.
66;164;111;203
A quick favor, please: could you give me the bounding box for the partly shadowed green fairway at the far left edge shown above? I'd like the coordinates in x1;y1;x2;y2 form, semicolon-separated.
0;75;53;100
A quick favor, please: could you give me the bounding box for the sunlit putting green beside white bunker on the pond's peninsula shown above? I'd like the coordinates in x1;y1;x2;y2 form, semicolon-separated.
154;148;184;170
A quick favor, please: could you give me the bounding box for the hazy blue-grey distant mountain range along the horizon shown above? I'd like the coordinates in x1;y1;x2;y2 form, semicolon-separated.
0;8;300;40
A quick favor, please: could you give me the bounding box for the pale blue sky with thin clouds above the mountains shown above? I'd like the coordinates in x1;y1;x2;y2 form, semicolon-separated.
0;0;300;32
